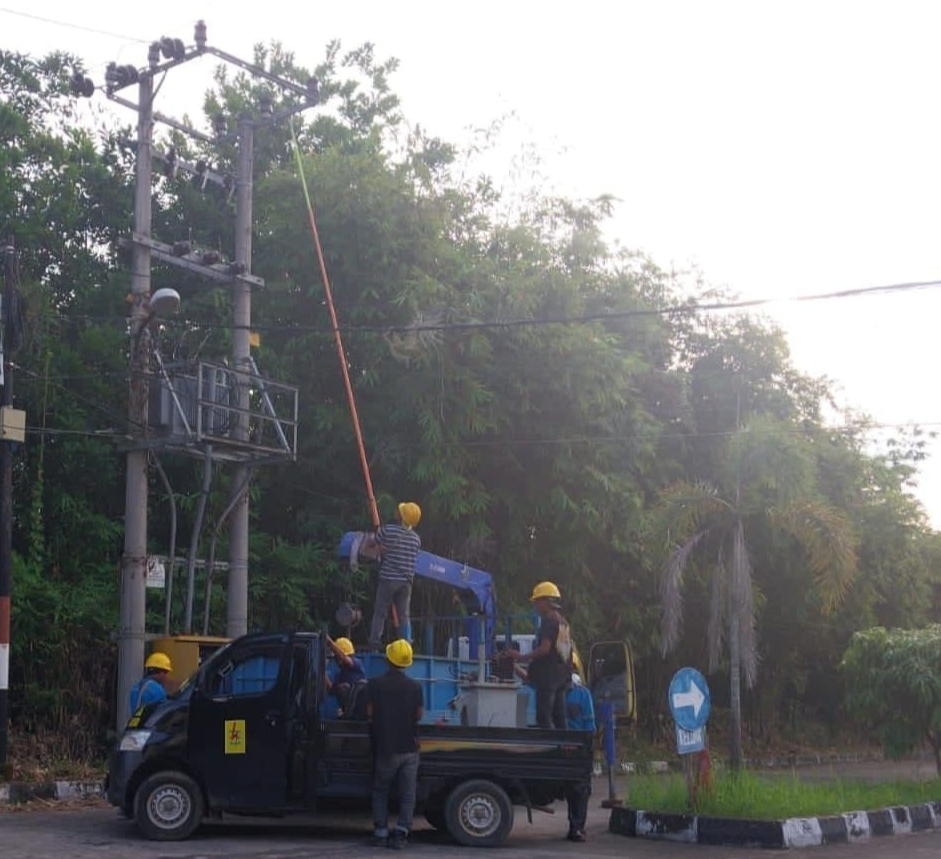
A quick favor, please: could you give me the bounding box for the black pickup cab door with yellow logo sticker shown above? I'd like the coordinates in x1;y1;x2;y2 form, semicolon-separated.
188;635;292;811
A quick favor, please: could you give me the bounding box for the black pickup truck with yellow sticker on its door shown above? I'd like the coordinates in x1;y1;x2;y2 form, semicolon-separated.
108;633;592;847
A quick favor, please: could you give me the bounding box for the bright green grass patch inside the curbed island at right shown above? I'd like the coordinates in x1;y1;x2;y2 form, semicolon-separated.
627;772;941;820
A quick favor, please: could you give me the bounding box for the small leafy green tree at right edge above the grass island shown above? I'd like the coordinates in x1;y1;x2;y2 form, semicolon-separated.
841;624;941;776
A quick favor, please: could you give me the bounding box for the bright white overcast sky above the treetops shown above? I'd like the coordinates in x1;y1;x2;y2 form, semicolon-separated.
0;0;941;528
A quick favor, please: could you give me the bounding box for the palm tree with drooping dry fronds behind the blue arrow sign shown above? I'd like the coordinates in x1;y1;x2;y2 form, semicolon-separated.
655;419;856;770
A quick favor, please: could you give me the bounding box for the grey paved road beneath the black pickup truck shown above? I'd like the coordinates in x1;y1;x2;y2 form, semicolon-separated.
0;785;941;859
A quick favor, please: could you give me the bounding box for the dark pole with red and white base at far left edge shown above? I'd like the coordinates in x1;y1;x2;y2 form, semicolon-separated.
0;237;16;777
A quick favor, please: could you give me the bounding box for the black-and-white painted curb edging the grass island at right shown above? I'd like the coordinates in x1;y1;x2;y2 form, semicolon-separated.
608;802;941;850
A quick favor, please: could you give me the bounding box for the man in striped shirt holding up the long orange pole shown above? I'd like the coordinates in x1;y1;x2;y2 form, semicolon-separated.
365;501;421;650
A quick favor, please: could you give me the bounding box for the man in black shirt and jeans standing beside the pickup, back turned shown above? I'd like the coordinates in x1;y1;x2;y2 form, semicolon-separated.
366;638;425;850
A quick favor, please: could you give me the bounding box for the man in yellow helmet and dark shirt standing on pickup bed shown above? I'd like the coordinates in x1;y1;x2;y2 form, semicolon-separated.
503;582;572;730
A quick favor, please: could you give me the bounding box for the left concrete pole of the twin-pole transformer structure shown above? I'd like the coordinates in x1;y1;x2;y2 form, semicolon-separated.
117;72;154;730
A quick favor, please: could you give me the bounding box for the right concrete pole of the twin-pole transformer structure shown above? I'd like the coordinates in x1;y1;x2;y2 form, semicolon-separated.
225;115;255;638
